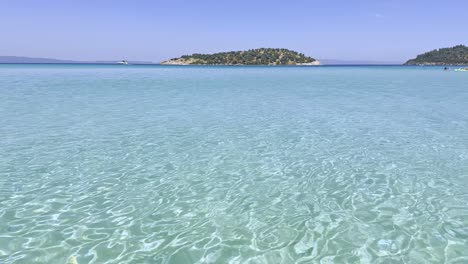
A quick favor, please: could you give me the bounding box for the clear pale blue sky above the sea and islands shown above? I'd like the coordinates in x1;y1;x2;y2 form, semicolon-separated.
0;0;468;62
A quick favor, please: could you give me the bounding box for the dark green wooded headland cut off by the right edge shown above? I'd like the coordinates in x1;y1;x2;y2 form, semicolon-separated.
405;45;468;65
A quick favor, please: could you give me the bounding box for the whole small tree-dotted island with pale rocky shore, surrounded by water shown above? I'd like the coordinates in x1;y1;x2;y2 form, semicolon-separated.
161;48;320;65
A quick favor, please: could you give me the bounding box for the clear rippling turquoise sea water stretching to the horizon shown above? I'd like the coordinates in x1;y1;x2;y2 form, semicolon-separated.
0;65;468;264
